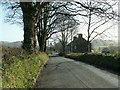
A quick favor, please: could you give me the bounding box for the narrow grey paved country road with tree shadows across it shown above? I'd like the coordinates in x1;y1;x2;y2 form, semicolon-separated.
37;56;118;88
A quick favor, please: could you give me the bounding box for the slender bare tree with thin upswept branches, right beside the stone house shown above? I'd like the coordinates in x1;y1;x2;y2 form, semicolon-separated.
79;1;117;52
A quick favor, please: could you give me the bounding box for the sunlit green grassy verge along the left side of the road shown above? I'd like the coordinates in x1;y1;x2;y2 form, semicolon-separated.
2;53;48;88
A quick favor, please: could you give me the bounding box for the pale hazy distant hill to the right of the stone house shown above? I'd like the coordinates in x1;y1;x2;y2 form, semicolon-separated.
92;39;118;48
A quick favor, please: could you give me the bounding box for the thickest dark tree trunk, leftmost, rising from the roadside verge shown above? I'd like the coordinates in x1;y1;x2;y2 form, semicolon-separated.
20;2;36;53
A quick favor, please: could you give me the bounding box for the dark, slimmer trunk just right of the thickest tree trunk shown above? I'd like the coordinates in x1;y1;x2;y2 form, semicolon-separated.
37;6;48;52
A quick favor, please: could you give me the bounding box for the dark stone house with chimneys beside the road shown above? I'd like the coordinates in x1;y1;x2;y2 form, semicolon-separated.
66;34;91;53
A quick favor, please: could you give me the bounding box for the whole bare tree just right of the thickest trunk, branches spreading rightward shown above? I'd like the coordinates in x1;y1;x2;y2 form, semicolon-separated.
37;2;79;51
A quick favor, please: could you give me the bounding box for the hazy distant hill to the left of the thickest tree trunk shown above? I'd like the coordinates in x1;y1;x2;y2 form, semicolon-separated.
0;41;22;48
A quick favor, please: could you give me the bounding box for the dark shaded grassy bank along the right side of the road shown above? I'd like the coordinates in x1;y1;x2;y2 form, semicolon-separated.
65;53;120;73
